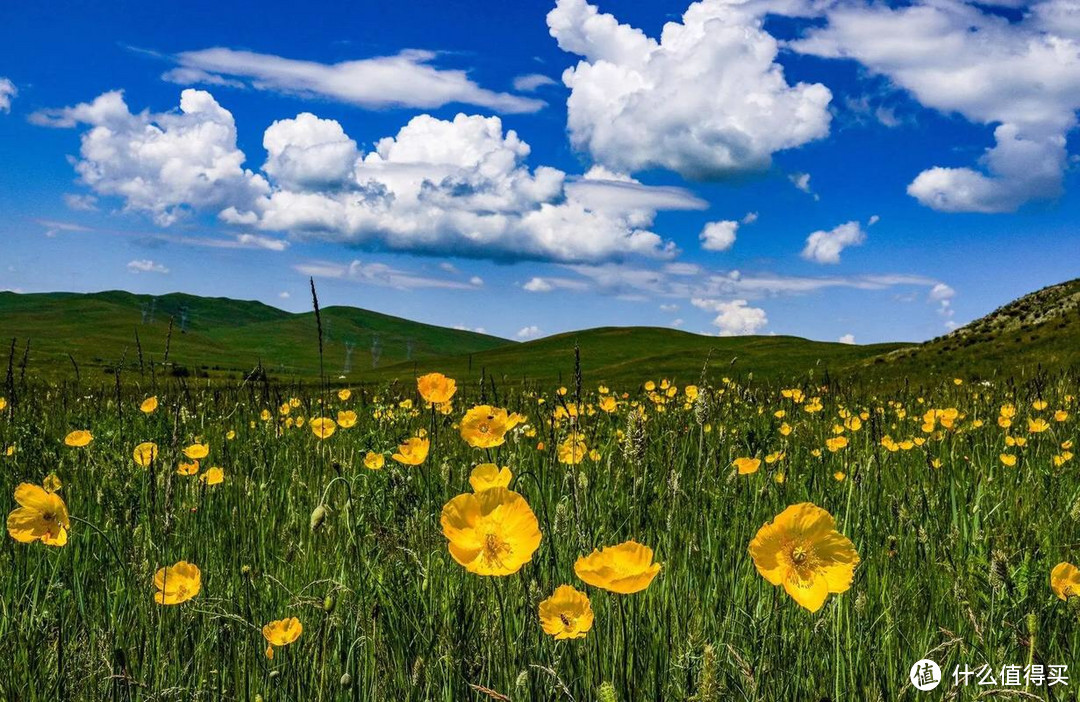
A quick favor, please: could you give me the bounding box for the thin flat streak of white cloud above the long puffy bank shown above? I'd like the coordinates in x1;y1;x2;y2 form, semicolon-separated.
172;48;544;112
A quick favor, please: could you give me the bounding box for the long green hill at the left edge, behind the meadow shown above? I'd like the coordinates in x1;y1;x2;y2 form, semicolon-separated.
0;291;513;377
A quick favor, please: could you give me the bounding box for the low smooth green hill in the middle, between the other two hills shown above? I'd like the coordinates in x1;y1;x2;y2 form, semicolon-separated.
380;327;899;383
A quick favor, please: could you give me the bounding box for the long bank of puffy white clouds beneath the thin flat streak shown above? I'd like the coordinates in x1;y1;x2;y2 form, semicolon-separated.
33;89;682;261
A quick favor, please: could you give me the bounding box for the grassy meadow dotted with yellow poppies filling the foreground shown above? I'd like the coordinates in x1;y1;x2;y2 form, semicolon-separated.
0;372;1080;702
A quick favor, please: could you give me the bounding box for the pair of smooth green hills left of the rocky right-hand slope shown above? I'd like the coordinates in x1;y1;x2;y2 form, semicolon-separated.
0;292;900;382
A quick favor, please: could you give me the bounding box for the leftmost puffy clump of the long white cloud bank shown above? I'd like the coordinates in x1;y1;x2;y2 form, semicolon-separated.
31;90;269;226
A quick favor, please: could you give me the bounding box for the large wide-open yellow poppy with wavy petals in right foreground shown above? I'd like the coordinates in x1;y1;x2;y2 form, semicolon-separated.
750;502;859;612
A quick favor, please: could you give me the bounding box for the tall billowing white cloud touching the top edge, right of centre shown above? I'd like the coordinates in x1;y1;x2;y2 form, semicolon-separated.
548;0;832;179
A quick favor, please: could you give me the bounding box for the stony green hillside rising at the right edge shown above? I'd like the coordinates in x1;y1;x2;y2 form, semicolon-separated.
864;279;1080;378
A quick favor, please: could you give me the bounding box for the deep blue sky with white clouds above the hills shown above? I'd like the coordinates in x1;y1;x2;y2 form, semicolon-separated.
0;0;1080;343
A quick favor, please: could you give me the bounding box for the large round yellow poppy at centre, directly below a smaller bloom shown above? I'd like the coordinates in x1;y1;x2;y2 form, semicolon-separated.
440;487;541;576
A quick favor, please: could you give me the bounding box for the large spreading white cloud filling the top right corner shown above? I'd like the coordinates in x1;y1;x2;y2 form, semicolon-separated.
792;0;1080;213
